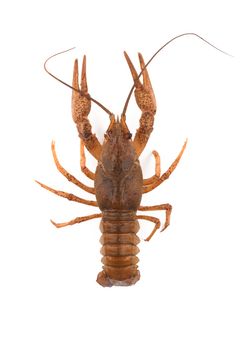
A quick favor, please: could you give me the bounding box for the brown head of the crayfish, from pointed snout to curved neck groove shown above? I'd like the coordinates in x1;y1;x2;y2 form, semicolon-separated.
101;116;138;177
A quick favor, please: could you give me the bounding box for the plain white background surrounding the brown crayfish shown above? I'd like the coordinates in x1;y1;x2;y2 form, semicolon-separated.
0;0;247;350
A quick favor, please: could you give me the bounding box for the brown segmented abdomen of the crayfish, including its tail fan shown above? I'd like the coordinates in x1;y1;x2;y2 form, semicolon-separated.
97;211;140;287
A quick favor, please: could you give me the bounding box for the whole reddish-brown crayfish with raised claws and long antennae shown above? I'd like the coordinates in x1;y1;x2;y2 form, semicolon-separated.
37;33;228;287
